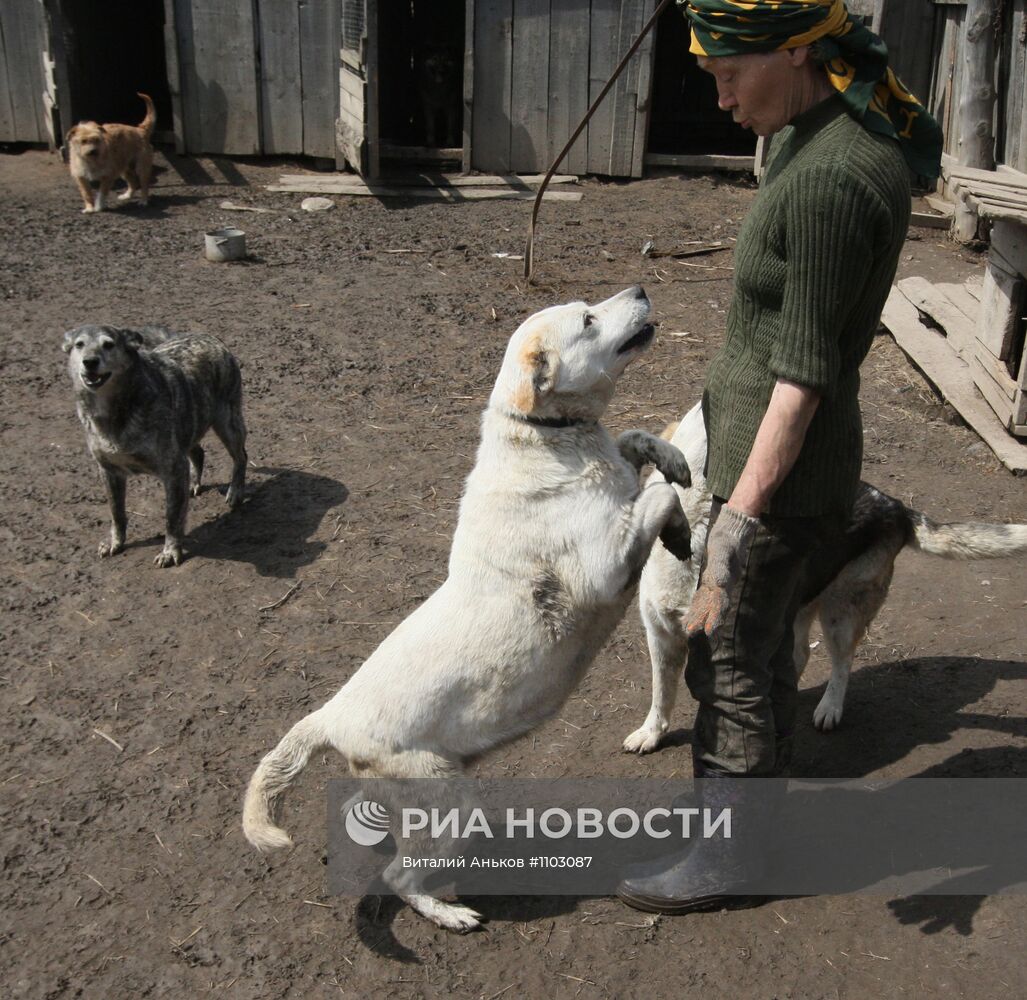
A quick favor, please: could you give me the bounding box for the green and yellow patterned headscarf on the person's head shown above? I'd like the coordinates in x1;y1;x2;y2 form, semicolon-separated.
678;0;942;178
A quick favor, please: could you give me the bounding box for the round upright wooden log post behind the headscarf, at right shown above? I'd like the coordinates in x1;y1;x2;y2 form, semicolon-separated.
953;0;997;242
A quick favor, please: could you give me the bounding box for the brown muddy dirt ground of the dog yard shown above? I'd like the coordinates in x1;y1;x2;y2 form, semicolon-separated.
0;151;1027;1000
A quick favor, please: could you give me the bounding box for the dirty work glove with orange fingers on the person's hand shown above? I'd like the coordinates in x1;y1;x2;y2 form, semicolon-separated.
685;504;760;642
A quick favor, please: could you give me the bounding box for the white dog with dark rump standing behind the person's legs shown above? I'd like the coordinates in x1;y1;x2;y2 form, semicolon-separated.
623;406;1027;754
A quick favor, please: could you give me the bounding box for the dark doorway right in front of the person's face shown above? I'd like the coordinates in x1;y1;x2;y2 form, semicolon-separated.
648;5;756;156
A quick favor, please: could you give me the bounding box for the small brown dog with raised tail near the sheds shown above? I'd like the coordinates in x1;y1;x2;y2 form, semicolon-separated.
65;93;157;211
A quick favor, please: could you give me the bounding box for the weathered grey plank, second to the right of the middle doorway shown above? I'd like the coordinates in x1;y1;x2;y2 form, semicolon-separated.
510;0;549;170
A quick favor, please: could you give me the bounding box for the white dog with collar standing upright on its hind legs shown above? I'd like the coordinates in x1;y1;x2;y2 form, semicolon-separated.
242;287;689;931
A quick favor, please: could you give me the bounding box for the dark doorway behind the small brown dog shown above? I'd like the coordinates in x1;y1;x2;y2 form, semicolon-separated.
48;0;173;131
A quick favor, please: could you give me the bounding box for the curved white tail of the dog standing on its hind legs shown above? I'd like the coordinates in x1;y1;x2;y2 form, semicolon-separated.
242;709;329;851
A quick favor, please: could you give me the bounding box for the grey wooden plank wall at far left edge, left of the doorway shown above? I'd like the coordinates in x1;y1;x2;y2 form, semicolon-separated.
0;0;49;143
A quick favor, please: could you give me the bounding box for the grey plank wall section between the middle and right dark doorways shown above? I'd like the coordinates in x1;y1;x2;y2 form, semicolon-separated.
471;0;655;177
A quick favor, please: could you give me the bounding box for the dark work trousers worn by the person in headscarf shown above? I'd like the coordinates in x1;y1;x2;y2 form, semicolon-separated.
685;499;845;776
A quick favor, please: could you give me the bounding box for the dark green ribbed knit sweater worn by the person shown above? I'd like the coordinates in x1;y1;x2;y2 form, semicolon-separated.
703;98;910;516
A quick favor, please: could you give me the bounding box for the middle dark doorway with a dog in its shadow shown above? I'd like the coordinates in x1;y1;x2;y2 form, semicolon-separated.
378;0;465;149
